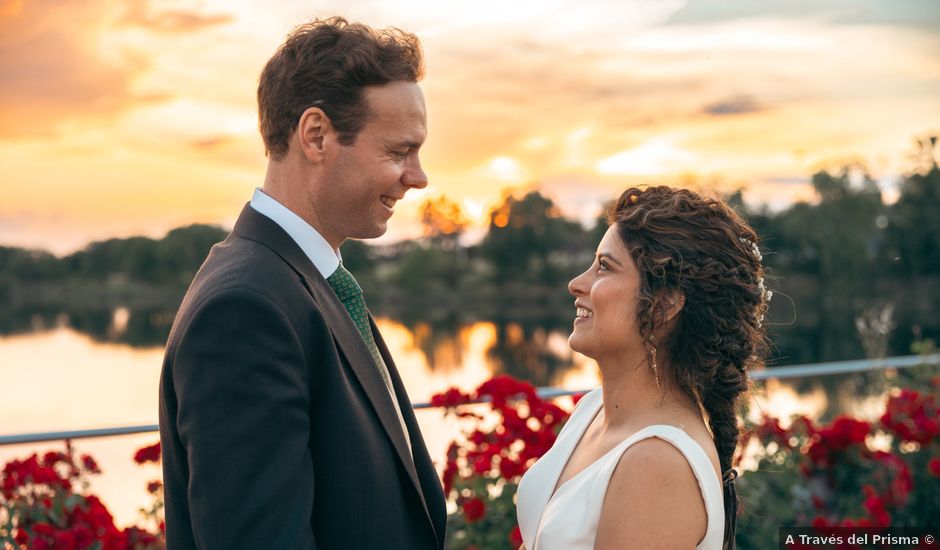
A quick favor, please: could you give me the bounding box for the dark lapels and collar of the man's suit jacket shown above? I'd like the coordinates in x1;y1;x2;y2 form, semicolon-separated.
234;204;437;533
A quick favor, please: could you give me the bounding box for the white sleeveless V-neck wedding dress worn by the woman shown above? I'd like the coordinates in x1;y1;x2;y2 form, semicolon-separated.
516;389;725;550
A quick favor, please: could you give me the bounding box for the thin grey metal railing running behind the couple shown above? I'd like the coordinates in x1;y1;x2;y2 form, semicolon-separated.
0;354;940;445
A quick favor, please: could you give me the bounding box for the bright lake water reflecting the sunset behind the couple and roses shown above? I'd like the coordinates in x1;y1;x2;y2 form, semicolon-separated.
0;322;881;525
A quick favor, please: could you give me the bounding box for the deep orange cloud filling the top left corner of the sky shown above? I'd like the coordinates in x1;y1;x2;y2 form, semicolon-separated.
0;0;233;140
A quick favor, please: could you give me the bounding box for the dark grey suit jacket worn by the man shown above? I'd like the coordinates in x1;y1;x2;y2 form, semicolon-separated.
160;205;446;550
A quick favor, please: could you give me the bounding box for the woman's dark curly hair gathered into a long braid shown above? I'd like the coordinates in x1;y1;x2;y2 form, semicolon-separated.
609;186;768;548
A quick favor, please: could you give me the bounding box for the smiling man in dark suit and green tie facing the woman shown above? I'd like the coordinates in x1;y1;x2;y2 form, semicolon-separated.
160;18;446;550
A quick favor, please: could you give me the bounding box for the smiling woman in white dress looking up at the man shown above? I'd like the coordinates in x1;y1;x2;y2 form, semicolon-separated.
517;187;771;550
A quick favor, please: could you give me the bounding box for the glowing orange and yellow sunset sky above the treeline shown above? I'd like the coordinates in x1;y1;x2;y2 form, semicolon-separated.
0;0;940;254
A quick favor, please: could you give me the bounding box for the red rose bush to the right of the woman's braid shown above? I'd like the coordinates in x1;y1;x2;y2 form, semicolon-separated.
737;377;940;549
